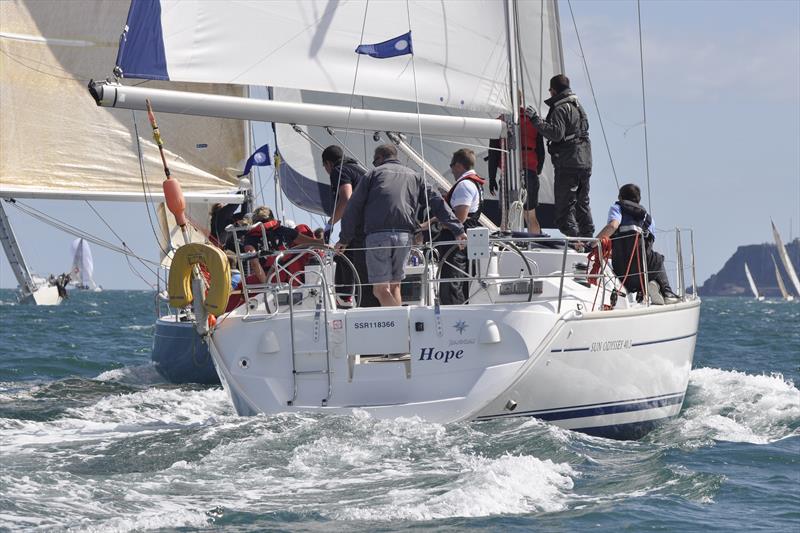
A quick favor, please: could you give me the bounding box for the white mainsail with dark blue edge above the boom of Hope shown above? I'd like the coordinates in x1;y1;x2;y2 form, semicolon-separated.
114;0;512;115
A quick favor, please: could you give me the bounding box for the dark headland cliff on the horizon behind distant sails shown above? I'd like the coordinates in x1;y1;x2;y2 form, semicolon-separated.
700;239;800;298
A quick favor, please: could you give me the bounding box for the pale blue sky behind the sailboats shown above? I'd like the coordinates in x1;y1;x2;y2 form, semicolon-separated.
0;0;800;289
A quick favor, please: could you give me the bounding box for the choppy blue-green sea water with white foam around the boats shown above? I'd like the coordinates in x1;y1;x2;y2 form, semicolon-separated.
0;291;800;533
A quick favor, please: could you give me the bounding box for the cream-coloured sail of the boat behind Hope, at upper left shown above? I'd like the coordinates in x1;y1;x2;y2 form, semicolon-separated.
0;0;247;199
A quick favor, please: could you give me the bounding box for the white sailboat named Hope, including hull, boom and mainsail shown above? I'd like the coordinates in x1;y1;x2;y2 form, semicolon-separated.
93;1;700;437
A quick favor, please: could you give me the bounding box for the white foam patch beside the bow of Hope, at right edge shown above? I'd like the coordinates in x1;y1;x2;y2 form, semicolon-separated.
681;368;800;444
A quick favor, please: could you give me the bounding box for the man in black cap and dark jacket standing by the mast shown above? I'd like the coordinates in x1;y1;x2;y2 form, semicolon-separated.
525;74;594;237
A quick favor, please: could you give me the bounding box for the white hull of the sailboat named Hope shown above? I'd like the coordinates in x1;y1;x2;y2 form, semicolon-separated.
209;243;700;438
